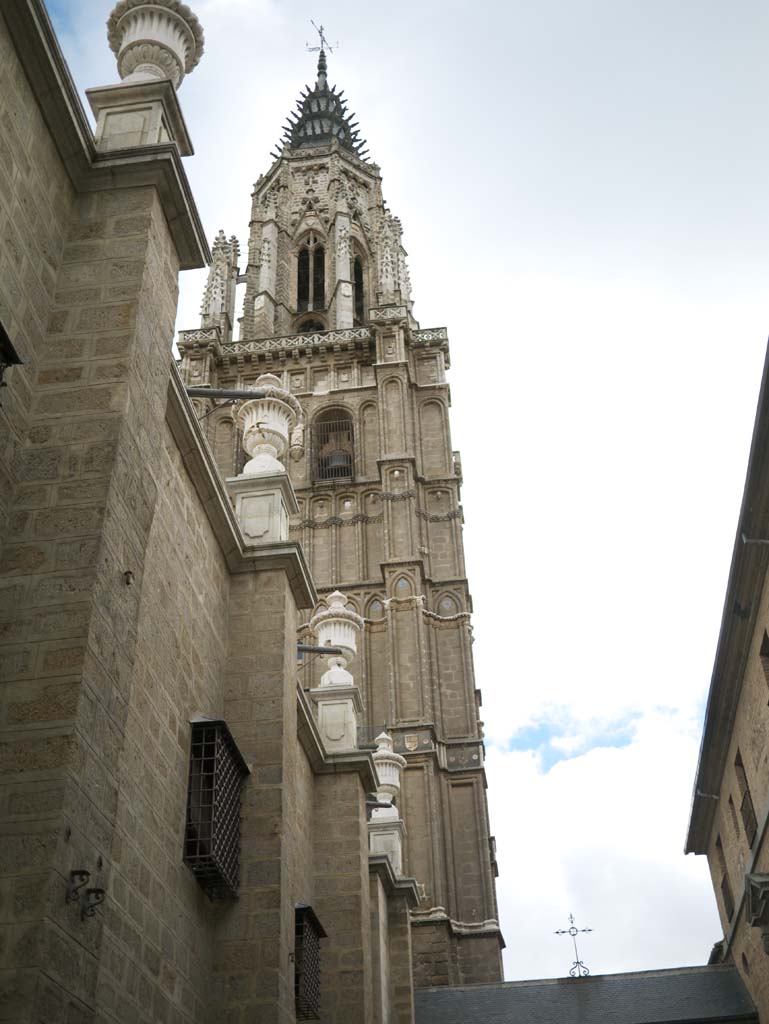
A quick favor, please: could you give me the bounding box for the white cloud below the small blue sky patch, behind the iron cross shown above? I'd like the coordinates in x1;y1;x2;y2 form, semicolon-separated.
486;714;721;979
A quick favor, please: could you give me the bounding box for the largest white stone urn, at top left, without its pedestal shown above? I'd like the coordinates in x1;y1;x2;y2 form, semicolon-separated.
106;0;204;89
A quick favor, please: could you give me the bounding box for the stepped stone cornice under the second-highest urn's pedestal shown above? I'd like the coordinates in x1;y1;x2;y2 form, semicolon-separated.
166;362;317;608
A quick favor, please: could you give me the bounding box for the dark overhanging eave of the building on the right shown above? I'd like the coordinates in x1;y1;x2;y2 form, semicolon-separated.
685;344;769;853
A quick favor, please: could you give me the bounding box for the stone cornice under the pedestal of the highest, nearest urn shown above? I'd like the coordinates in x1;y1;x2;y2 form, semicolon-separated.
3;0;210;270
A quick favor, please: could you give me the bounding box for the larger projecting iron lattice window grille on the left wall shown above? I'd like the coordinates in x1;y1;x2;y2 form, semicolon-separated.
183;720;249;900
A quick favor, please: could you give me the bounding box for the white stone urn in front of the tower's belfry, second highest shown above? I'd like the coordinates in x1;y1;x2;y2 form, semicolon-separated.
238;374;302;476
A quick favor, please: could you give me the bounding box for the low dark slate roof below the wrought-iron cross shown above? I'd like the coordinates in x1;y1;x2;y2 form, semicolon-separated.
414;964;758;1024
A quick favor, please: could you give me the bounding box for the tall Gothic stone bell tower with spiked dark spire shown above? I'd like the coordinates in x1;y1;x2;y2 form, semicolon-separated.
179;50;503;986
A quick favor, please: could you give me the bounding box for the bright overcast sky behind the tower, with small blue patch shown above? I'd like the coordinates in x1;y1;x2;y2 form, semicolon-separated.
51;0;769;979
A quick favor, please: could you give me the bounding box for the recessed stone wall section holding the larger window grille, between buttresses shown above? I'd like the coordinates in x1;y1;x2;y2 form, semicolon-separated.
96;419;229;1021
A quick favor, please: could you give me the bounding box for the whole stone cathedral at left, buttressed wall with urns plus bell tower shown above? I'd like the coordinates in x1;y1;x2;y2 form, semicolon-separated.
0;0;501;1024
